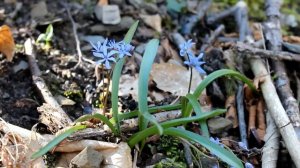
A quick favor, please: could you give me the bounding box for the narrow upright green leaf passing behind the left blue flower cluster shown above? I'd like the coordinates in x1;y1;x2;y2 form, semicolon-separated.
111;21;139;134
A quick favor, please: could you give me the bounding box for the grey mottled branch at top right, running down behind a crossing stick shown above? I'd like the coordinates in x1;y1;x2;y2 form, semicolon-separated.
264;0;300;131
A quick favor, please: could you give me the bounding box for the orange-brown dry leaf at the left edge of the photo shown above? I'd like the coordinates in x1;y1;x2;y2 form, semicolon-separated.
0;25;15;62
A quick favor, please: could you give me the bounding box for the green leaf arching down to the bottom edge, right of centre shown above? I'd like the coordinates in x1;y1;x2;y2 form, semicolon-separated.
164;128;243;168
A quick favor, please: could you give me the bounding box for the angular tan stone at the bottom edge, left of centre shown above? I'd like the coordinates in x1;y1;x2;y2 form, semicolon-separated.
69;146;103;168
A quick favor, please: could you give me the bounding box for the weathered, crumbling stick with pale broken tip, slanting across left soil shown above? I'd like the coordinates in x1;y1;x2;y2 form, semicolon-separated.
24;39;72;132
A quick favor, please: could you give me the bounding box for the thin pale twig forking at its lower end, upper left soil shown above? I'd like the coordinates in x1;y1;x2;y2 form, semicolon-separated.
61;2;95;69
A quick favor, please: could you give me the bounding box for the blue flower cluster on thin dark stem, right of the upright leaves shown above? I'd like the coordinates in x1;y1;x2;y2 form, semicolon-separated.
179;40;206;75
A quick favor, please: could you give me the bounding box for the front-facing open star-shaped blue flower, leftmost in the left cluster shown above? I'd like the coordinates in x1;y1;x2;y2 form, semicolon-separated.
93;39;118;69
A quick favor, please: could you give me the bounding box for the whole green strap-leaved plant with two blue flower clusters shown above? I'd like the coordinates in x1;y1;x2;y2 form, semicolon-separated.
32;22;255;168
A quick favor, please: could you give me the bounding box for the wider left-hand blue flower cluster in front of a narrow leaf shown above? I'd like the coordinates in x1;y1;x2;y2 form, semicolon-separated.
90;39;134;69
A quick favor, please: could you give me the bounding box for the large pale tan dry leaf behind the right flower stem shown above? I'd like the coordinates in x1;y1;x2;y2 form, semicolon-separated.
151;63;202;96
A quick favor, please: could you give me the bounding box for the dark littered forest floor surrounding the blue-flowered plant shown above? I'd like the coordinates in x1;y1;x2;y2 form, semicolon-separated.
0;0;300;167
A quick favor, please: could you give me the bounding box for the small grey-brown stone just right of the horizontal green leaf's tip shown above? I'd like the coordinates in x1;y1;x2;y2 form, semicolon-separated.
207;117;232;134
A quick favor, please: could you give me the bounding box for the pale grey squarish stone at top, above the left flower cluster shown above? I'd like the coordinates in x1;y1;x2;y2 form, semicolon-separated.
95;5;121;25
